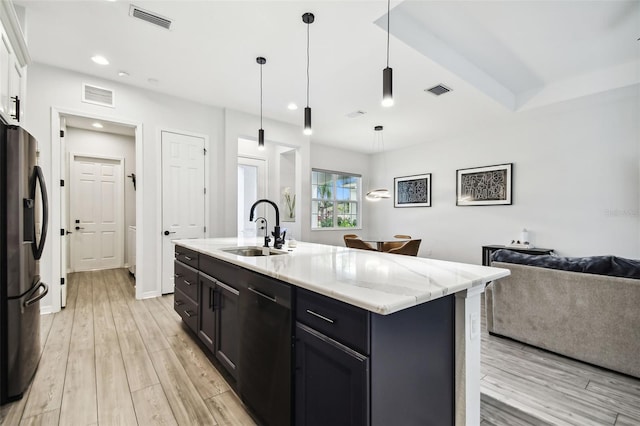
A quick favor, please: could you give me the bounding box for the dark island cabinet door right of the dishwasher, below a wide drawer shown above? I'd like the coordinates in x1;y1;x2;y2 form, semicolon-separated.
295;323;369;426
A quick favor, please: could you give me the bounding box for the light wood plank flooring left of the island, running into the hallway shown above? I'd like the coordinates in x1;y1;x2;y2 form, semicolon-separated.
0;269;255;426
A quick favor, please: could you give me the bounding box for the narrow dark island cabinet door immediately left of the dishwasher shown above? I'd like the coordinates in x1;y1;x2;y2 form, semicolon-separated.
216;281;240;379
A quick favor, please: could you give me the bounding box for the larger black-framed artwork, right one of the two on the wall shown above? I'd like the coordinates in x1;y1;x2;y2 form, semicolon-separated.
456;163;513;206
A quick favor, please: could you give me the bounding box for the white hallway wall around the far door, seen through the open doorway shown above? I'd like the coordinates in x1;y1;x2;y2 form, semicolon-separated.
62;127;136;267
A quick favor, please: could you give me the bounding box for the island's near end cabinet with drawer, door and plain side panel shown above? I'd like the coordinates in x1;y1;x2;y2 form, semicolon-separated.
295;288;455;426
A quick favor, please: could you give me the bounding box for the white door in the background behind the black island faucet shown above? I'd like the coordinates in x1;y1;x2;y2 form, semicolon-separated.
238;157;266;237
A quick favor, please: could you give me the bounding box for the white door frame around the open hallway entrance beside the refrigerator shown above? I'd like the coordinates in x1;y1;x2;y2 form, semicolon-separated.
51;106;146;314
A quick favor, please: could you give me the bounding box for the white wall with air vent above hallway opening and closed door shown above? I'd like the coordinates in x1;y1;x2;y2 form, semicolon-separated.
24;63;225;312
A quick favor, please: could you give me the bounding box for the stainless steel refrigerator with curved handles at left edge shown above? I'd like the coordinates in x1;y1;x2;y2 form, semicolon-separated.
0;122;49;404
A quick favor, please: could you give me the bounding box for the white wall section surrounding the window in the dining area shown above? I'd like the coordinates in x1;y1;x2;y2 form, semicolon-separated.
305;144;370;246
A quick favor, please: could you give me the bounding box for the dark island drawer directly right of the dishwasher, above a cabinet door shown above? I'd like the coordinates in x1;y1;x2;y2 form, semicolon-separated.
296;288;370;355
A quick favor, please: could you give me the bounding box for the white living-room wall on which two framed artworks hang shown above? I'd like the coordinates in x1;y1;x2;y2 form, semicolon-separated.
370;88;640;263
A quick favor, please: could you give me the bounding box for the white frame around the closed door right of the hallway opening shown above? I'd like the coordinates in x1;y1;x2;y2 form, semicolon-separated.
158;127;213;297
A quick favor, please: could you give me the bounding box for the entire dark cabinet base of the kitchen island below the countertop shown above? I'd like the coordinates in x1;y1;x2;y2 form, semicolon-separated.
175;247;455;426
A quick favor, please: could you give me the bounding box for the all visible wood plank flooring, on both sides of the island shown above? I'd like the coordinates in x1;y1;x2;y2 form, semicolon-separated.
0;269;640;426
